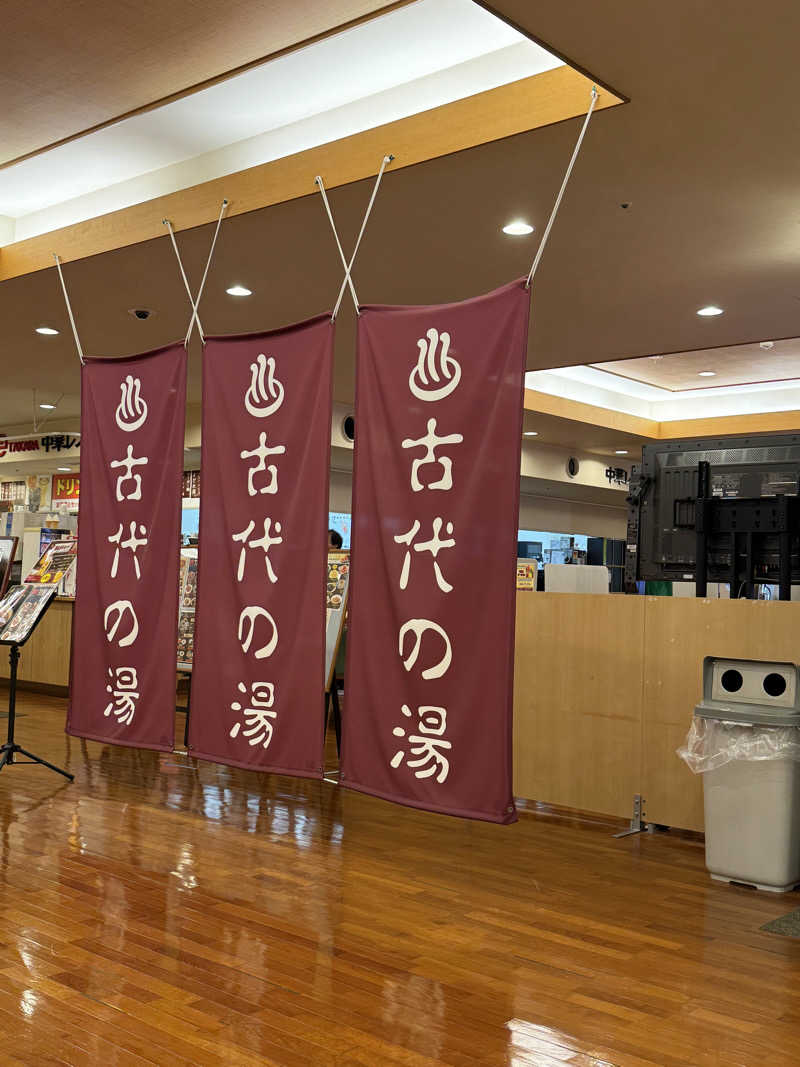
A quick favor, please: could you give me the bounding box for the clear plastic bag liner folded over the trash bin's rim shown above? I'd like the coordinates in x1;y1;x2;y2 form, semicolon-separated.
676;717;800;775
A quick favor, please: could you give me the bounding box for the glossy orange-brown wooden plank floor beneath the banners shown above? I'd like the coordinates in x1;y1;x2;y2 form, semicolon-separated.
0;692;800;1067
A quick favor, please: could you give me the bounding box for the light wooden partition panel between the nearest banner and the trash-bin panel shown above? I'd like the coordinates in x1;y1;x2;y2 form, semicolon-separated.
514;593;644;816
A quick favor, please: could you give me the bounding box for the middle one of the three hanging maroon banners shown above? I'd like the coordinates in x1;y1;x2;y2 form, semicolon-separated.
189;315;334;778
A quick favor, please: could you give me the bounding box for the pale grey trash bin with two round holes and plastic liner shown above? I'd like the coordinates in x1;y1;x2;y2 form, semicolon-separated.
678;658;800;893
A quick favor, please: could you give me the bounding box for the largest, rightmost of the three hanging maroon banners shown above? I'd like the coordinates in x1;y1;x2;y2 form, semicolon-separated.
340;282;529;823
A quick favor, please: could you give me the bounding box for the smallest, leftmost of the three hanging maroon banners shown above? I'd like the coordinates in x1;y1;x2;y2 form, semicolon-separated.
67;345;187;752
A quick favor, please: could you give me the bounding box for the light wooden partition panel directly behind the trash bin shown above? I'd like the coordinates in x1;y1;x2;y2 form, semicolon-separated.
641;596;800;830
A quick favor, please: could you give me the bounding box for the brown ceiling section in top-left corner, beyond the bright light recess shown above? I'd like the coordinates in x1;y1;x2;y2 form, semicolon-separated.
0;0;409;164
